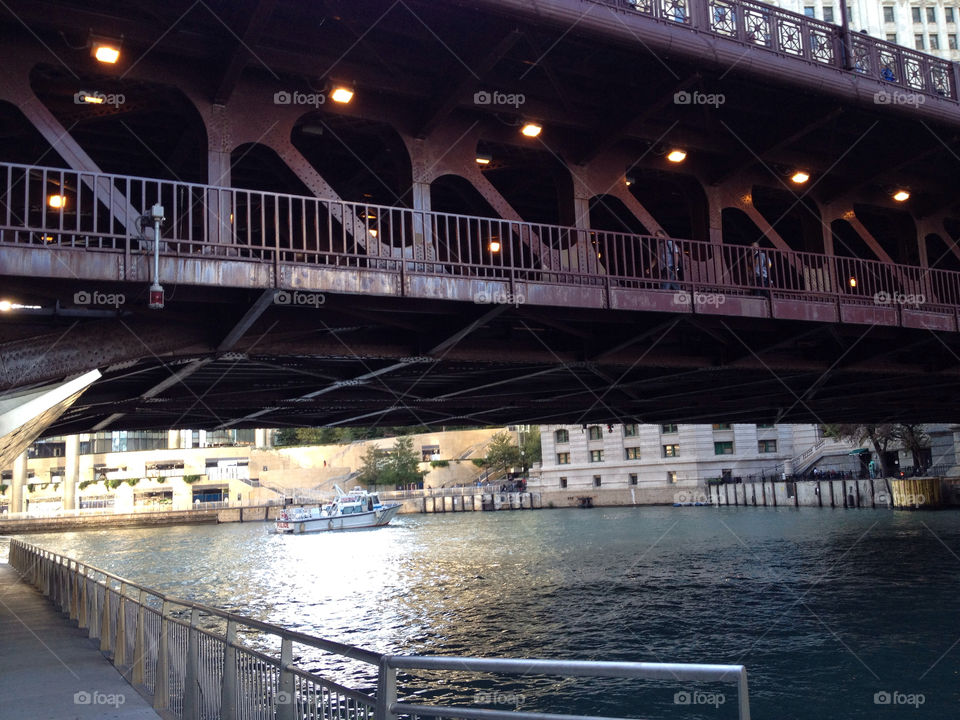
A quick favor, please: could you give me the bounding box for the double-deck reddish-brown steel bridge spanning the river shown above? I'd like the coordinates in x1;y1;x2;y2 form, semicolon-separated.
0;0;960;433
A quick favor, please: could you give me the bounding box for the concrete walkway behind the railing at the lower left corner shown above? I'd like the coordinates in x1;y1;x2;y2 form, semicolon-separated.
0;563;159;720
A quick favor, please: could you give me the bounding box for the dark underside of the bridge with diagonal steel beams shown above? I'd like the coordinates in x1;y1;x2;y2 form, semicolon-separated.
5;278;960;433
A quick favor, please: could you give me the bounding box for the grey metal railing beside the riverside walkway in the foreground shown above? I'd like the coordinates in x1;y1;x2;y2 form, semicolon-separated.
8;539;750;720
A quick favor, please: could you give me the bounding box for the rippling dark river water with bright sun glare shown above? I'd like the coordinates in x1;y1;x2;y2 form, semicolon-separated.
9;507;960;720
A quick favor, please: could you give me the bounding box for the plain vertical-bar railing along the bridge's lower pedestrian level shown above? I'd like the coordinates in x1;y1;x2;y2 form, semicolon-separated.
0;163;960;314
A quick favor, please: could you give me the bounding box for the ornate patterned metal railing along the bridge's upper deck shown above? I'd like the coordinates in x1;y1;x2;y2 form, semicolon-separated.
583;0;958;103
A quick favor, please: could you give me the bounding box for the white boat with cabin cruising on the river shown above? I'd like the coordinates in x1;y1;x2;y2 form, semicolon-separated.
276;485;400;534
